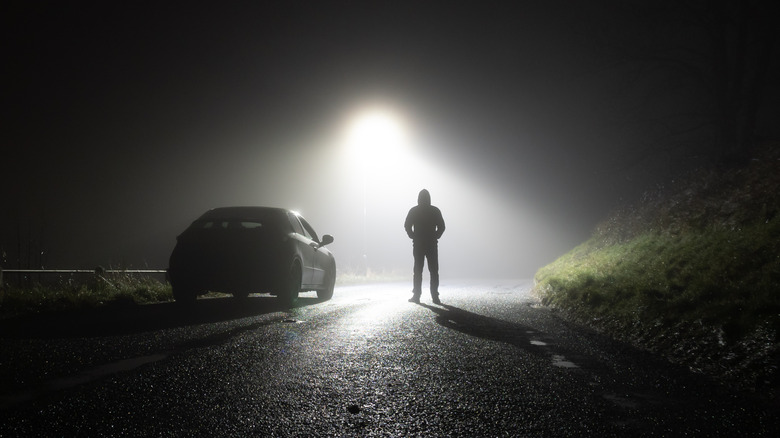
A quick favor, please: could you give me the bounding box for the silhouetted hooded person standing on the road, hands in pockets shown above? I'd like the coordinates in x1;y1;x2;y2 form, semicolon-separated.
404;189;444;304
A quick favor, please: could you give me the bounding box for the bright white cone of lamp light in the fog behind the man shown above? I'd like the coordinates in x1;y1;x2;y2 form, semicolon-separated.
316;99;561;281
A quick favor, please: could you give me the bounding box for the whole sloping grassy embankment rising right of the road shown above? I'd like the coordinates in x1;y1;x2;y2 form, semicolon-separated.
535;144;780;392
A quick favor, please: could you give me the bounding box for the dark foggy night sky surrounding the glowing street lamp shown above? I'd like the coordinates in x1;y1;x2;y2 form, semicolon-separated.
0;1;777;277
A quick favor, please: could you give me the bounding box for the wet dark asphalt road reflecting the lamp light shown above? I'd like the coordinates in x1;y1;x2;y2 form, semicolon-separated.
0;280;780;437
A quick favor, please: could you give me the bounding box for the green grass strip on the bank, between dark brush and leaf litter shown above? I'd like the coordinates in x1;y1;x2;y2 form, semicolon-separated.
536;219;780;338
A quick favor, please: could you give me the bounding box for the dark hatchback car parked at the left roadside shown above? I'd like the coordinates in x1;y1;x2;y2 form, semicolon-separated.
168;207;336;305
